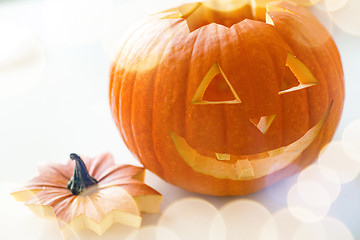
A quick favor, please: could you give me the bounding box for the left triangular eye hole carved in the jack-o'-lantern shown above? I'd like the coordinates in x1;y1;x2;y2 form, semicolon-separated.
191;63;241;104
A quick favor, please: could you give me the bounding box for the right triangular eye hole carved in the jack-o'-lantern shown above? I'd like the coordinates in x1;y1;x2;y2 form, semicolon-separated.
278;53;318;95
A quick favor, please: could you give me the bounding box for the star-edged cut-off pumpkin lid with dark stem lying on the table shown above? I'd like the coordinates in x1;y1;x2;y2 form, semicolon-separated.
12;153;161;238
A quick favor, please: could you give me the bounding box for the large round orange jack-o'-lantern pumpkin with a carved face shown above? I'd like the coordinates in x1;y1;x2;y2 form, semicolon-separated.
109;2;344;196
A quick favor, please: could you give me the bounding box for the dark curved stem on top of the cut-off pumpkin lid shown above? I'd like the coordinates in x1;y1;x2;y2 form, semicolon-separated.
67;153;98;195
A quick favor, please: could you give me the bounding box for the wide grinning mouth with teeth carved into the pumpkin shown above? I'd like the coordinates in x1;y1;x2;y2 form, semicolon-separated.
170;102;332;180
